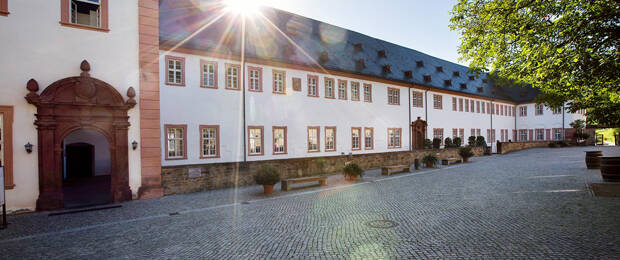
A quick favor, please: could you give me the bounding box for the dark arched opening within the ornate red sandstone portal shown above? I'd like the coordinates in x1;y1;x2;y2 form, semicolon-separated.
62;129;112;208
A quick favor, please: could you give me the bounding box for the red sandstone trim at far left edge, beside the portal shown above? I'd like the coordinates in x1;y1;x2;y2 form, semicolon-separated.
0;106;15;190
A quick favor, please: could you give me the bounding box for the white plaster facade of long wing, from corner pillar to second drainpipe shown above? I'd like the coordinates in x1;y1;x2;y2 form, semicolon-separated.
160;52;410;165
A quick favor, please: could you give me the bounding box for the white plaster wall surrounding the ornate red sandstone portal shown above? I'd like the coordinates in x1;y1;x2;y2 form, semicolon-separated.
0;0;140;209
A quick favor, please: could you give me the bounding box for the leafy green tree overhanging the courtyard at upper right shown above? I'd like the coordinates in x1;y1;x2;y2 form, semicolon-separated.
450;0;620;126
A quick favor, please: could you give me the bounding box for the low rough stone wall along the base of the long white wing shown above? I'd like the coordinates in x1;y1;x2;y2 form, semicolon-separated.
162;147;482;195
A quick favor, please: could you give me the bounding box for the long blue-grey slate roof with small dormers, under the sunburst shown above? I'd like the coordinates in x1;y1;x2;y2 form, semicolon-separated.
159;0;539;102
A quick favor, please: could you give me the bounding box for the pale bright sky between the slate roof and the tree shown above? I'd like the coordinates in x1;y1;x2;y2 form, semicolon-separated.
250;0;467;65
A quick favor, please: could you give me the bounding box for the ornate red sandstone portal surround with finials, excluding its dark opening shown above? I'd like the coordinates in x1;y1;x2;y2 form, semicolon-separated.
26;61;136;210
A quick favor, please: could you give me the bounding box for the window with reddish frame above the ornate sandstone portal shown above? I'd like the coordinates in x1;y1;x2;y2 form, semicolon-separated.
60;0;109;31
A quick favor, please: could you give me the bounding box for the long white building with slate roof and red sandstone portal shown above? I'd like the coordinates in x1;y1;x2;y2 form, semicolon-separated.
0;0;584;210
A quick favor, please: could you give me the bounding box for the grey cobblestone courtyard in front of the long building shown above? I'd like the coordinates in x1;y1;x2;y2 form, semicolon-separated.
0;147;620;259
